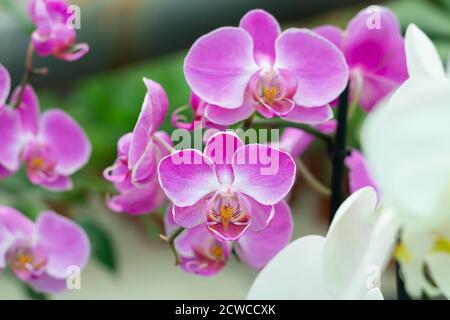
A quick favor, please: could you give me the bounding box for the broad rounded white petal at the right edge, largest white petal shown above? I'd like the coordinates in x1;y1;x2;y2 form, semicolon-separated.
362;80;450;228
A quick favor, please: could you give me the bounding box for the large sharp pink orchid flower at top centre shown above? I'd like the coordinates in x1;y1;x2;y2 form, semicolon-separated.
184;10;348;125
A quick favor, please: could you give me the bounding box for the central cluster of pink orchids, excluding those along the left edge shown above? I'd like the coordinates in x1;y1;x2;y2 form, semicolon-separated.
104;8;408;276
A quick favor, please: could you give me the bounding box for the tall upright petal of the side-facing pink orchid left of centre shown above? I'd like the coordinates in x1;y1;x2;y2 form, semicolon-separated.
128;78;169;169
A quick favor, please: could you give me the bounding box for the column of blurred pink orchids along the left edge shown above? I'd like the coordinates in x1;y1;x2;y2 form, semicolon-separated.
0;0;91;293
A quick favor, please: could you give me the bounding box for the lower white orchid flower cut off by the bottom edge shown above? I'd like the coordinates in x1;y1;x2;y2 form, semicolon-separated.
248;187;398;299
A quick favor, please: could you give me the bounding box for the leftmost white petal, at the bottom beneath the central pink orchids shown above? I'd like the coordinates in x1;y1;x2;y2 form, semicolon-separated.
248;236;332;300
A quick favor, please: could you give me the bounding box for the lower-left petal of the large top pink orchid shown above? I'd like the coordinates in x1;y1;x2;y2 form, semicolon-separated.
205;95;255;126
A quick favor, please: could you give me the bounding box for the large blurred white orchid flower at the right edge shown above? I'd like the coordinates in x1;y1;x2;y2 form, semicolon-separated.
362;25;450;298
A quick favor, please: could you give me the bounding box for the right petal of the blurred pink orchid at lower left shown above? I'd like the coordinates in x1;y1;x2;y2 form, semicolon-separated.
35;211;90;279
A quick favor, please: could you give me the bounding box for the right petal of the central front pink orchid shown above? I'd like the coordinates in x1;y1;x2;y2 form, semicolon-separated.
233;144;295;205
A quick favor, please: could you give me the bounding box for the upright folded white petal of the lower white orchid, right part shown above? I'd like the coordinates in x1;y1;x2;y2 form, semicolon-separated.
323;187;398;299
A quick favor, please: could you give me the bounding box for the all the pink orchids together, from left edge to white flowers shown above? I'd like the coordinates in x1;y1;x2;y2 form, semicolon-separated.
0;0;408;292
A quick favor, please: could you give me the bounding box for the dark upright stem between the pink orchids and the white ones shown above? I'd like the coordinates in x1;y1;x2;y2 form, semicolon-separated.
329;86;349;224
